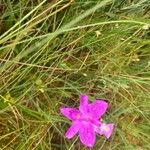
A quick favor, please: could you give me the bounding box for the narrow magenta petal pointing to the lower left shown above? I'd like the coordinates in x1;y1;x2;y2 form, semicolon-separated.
65;121;80;139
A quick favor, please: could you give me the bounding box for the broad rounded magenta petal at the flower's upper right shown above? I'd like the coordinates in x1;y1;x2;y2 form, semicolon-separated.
88;100;108;119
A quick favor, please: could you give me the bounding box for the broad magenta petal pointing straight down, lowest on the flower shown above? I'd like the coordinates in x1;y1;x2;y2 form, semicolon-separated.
79;123;96;147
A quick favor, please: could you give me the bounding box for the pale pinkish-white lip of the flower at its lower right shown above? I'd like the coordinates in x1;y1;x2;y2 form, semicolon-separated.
96;123;114;139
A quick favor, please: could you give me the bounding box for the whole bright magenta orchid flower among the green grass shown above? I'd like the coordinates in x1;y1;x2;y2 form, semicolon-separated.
60;95;114;147
